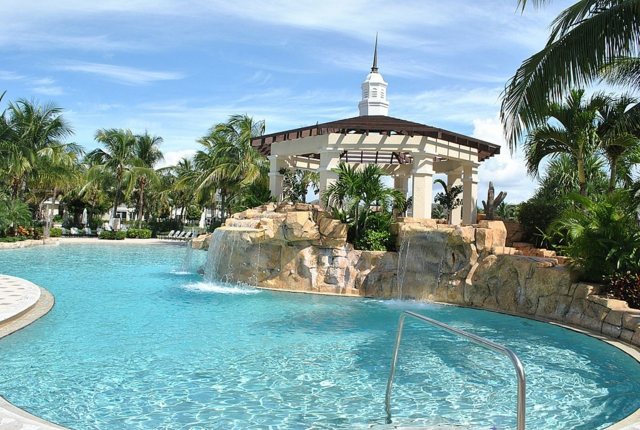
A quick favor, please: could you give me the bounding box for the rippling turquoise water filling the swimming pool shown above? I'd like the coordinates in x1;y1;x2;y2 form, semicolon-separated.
0;245;640;430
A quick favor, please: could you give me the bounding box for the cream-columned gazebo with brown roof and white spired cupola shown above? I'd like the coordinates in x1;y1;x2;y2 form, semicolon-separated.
252;41;500;224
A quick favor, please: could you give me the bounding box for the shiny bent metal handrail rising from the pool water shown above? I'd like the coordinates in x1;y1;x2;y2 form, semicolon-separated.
384;311;527;430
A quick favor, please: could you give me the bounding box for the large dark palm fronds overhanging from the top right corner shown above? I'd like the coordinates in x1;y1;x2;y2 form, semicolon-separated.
500;0;640;150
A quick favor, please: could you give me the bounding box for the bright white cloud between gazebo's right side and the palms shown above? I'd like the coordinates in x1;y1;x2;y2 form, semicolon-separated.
473;117;536;204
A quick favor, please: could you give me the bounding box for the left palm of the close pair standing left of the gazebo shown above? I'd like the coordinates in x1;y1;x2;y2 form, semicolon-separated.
87;128;136;218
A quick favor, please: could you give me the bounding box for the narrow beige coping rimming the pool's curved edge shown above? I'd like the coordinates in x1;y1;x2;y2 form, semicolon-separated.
0;275;640;430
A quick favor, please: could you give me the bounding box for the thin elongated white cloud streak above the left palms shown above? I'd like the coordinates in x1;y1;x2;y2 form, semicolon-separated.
56;61;184;85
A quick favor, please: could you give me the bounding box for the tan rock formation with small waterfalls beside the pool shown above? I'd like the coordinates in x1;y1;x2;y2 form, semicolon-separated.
193;203;640;345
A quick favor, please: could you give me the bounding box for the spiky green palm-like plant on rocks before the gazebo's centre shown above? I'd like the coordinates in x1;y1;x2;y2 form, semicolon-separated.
322;162;406;249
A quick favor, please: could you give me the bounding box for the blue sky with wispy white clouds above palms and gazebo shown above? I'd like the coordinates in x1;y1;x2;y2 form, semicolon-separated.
0;0;569;202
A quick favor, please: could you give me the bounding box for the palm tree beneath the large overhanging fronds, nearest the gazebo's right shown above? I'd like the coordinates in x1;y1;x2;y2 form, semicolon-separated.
525;90;607;195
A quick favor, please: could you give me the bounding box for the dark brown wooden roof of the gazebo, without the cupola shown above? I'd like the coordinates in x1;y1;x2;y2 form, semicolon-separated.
251;115;500;161
